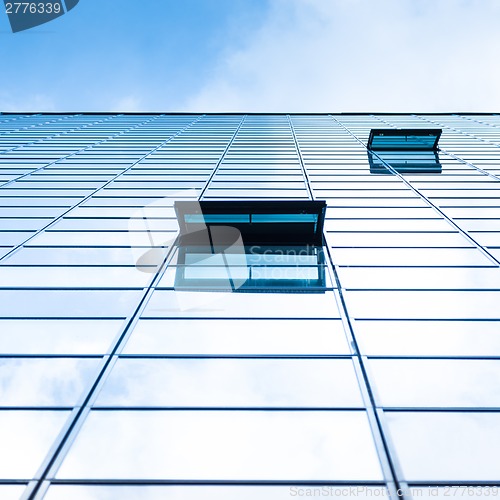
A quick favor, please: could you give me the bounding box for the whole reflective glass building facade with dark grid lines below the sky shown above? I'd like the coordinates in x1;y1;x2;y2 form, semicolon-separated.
0;114;500;500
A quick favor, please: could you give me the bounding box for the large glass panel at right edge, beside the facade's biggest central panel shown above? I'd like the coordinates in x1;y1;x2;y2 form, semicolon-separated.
385;412;500;482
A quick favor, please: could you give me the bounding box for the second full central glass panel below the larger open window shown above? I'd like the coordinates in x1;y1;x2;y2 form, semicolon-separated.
123;319;352;355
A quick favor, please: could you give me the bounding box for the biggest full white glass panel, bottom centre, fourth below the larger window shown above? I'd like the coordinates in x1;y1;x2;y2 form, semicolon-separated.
57;411;382;481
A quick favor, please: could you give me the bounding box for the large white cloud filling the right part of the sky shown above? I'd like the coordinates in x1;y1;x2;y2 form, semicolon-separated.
185;0;500;112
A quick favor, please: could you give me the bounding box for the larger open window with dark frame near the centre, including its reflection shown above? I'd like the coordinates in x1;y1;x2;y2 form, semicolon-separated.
169;201;328;292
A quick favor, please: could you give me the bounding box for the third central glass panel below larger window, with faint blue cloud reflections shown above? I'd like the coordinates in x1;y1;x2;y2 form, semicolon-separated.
97;359;363;407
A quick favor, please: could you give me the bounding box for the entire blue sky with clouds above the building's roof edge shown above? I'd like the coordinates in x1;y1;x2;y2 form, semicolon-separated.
0;0;500;112
